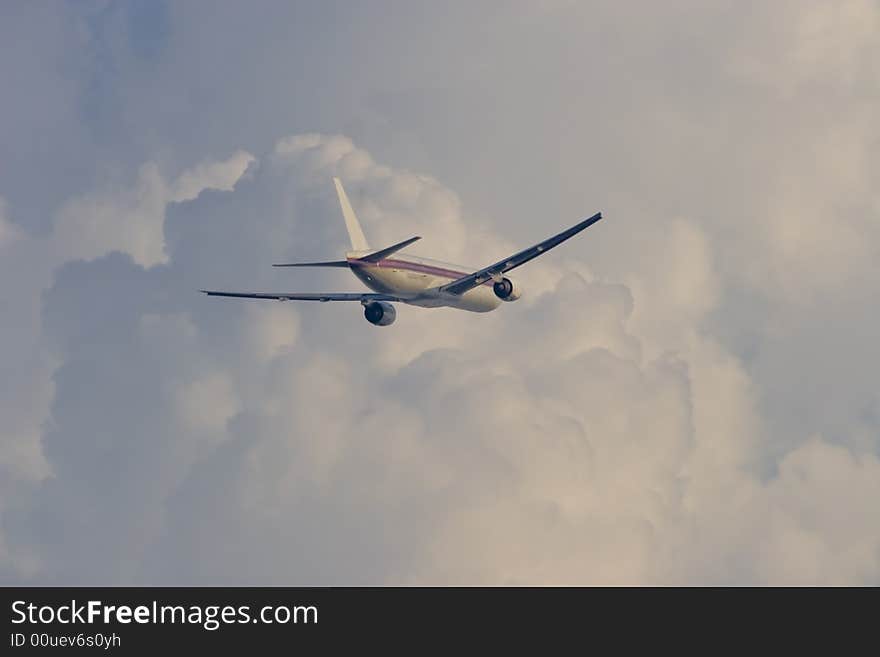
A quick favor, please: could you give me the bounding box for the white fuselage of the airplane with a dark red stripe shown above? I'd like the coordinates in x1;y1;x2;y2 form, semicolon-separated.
345;251;501;313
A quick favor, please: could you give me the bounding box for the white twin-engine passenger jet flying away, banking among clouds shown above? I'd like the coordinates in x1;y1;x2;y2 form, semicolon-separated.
200;178;602;326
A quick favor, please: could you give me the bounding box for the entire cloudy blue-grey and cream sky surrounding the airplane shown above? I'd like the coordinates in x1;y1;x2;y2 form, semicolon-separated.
0;0;880;585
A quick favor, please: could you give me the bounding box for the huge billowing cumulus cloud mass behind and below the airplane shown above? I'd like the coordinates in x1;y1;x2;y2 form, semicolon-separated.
5;134;880;584
